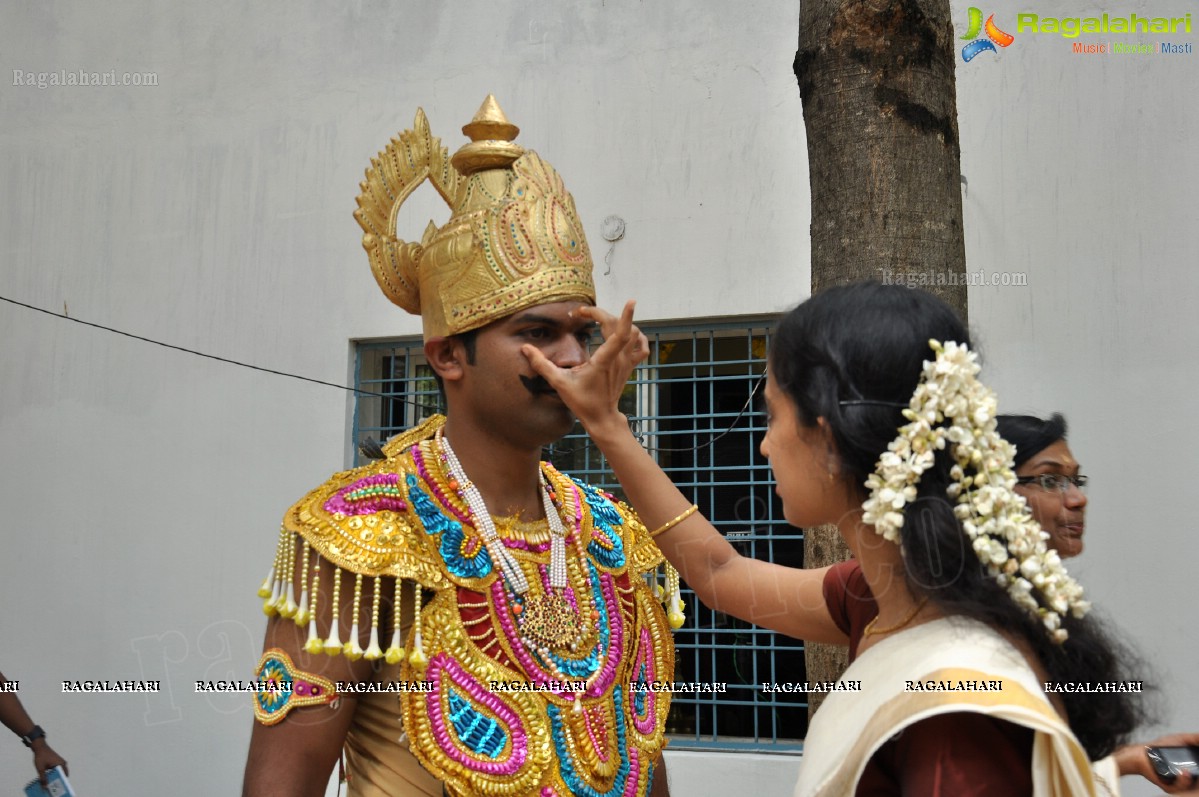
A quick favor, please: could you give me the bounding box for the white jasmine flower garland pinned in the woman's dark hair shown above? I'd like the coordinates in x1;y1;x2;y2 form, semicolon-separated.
862;340;1090;642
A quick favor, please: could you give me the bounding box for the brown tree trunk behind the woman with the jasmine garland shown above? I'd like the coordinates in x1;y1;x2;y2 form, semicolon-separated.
794;0;966;717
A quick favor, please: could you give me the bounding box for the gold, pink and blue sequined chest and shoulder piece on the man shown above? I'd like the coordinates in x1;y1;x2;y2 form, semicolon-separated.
256;416;681;797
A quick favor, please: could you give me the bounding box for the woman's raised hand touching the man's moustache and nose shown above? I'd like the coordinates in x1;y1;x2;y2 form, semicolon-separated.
520;300;650;437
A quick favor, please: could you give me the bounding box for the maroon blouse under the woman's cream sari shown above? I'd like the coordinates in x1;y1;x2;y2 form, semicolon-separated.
824;560;1032;797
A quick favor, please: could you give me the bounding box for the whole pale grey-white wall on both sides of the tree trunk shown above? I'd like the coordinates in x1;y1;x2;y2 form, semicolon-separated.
0;0;1199;795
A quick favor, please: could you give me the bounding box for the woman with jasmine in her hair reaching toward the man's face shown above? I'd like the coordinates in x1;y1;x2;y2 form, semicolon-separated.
526;283;1139;797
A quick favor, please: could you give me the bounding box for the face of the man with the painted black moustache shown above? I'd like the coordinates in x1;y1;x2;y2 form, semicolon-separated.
453;302;596;448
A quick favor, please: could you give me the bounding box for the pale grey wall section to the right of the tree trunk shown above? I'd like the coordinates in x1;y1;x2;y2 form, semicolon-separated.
953;0;1199;795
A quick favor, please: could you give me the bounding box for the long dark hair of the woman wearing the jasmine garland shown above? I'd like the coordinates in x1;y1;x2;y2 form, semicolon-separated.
770;283;1143;759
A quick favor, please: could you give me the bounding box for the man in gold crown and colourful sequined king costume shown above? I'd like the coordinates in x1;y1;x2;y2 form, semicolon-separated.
245;97;681;797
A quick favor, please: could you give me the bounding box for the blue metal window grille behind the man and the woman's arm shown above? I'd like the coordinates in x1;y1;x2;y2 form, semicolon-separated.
354;319;807;751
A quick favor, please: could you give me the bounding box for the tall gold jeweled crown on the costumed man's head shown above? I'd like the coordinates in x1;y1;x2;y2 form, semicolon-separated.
354;95;595;340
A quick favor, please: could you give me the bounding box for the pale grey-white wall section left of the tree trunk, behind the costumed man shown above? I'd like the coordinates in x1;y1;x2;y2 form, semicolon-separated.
0;0;808;796
